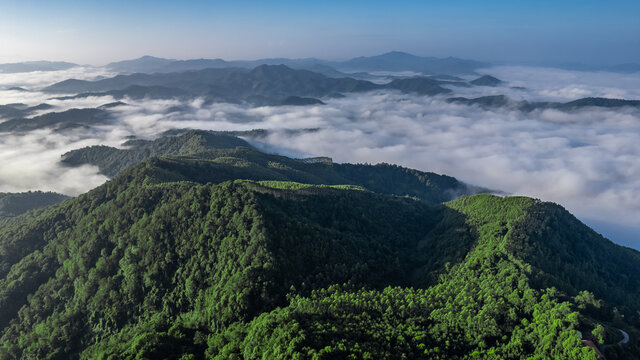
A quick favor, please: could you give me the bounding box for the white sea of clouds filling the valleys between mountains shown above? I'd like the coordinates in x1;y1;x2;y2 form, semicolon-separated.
0;66;640;247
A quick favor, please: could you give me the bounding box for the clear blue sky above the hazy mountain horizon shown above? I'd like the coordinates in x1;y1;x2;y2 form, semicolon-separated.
0;0;640;64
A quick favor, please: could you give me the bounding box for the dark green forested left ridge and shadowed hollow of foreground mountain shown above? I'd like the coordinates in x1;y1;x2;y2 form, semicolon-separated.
0;173;470;358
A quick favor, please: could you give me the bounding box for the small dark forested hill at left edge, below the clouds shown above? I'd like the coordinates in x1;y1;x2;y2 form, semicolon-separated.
0;191;69;219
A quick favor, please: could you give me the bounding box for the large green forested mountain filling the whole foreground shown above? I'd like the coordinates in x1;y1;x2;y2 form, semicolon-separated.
0;139;640;360
